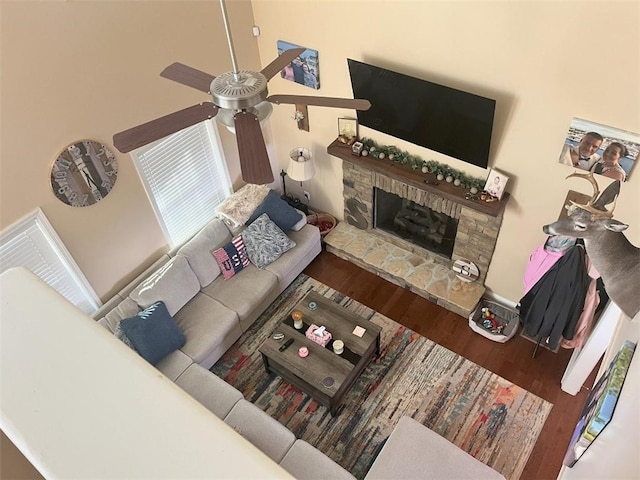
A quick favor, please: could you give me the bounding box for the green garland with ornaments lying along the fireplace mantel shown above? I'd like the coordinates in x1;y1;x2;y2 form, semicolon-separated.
360;137;485;190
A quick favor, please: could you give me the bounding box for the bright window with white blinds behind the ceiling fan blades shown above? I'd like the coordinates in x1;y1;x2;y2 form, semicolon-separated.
131;120;231;248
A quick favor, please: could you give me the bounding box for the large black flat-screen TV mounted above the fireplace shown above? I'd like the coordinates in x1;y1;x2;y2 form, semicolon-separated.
347;58;496;168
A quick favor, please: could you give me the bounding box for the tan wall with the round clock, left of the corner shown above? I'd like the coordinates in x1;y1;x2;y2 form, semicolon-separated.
0;0;260;300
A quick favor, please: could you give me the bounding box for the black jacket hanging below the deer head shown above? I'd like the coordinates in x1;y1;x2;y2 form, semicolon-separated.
520;245;590;349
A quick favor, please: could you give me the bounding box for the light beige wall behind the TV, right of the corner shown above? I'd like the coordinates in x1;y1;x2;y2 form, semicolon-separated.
253;0;640;301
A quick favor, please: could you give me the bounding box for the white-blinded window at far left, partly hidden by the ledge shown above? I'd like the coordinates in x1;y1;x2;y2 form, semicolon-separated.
0;209;100;315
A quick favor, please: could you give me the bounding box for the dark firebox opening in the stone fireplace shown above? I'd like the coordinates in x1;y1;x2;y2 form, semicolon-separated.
373;188;458;259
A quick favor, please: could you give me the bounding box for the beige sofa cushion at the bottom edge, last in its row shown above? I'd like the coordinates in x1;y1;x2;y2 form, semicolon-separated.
280;440;358;480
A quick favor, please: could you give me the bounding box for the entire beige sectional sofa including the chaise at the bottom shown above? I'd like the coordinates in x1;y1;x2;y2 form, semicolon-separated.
89;186;503;480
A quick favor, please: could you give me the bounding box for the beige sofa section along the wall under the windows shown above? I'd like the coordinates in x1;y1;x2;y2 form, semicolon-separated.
95;208;321;380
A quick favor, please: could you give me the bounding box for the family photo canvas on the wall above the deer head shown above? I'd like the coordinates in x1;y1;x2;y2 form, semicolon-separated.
559;118;640;182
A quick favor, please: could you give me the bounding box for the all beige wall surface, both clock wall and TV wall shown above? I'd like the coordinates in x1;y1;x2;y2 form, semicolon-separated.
0;0;640;301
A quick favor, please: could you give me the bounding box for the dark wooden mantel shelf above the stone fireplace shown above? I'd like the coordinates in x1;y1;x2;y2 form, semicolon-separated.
327;140;510;217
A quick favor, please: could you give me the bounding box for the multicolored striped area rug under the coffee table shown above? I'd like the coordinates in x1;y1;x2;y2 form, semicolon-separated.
211;275;552;479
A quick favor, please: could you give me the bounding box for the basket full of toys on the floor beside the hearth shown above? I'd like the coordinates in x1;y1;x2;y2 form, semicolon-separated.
469;298;520;343
